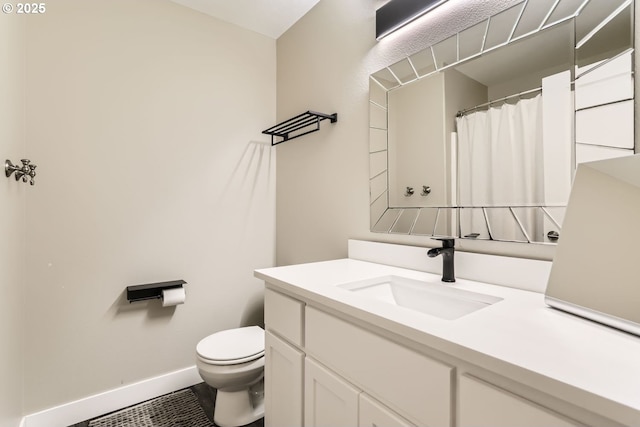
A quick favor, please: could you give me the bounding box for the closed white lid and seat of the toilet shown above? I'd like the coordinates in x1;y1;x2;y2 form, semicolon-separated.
196;326;264;362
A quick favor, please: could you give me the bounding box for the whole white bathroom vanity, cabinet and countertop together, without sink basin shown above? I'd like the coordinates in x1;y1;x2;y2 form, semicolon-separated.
255;249;640;427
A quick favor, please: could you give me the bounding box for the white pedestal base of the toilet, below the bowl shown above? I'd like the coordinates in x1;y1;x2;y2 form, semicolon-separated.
213;381;264;427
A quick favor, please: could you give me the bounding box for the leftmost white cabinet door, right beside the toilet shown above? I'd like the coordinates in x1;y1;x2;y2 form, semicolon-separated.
264;331;304;427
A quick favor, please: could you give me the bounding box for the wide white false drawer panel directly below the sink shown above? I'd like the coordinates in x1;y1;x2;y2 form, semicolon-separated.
305;307;455;427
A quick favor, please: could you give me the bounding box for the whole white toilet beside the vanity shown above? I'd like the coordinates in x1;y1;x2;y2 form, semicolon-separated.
196;326;264;427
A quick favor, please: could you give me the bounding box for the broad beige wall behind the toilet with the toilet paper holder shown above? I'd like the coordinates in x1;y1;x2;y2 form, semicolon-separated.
22;0;276;413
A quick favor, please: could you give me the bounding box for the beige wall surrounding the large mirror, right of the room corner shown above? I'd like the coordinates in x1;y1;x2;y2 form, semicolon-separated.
276;0;564;265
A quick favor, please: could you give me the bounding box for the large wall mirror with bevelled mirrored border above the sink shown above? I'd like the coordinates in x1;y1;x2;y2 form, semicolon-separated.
369;0;634;243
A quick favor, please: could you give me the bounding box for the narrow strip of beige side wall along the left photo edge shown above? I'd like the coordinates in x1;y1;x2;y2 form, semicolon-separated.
0;13;26;426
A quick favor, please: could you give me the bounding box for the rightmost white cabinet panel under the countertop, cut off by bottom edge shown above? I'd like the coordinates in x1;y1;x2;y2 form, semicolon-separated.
458;375;579;427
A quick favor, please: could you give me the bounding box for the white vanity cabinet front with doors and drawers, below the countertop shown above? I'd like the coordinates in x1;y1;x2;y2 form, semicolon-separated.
265;285;628;427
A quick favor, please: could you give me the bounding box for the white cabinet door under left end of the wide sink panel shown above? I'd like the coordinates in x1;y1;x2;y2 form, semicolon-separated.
304;358;360;427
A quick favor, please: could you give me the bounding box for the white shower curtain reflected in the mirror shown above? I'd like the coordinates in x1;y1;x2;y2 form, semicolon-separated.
456;95;544;238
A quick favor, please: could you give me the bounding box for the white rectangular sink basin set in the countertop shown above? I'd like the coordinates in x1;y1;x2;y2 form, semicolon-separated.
338;276;502;320
